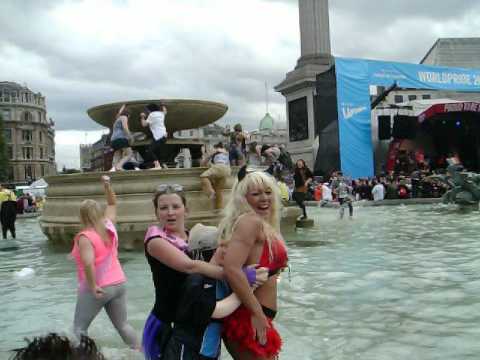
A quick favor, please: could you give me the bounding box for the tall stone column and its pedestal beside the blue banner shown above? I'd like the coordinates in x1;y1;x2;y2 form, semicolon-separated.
275;0;333;168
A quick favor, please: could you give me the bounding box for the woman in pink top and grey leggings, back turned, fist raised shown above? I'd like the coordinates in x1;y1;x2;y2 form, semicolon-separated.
72;176;140;349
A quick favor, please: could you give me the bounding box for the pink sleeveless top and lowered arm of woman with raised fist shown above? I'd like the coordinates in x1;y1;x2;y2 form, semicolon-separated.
72;220;127;290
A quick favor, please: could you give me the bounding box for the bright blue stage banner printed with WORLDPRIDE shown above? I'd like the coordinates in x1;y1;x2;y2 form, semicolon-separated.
335;58;480;179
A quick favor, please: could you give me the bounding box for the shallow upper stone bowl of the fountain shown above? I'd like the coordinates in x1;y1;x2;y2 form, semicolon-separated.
87;99;228;133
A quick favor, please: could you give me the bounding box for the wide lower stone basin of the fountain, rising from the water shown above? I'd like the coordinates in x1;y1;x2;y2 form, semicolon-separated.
39;167;300;249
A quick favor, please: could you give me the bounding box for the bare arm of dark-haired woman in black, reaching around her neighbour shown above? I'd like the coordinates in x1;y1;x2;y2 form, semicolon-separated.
147;237;223;280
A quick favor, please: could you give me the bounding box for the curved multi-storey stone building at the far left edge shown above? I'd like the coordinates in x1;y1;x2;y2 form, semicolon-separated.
0;81;56;183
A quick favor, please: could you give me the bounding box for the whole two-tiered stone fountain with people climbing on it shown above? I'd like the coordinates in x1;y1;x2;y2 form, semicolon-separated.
40;99;300;249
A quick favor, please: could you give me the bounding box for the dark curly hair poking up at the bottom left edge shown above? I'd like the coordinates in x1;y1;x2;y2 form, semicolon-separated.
11;333;105;360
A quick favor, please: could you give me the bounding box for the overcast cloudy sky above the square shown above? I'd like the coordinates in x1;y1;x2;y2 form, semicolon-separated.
0;0;480;168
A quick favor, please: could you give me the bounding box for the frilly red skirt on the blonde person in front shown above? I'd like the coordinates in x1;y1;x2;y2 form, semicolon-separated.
223;305;282;357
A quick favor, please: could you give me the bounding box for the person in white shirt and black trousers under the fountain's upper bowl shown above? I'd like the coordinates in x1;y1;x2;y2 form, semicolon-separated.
140;103;167;169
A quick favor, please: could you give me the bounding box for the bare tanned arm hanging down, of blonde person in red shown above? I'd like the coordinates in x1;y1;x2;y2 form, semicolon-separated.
224;215;268;344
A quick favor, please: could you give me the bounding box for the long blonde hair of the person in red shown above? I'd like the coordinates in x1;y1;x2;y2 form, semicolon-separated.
218;171;281;249
